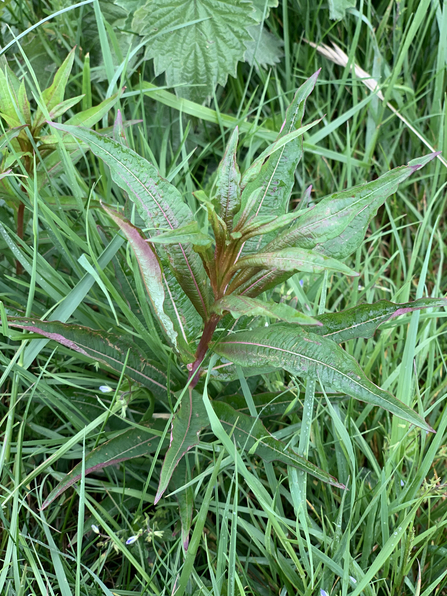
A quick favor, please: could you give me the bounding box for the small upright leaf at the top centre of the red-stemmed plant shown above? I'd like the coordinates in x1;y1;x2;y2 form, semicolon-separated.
215;126;241;232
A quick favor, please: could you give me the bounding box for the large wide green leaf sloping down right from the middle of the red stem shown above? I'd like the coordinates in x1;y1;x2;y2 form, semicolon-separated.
214;325;433;431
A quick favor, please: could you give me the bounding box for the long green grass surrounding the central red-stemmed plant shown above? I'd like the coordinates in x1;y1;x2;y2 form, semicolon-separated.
0;0;447;596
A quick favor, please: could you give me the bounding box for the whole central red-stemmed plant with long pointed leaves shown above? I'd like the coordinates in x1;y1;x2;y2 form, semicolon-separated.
2;73;446;528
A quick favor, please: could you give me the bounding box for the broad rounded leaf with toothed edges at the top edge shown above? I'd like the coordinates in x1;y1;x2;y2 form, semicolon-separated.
132;0;255;103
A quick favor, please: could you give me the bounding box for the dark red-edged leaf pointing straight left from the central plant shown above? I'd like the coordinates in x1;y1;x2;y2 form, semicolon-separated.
1;317;171;399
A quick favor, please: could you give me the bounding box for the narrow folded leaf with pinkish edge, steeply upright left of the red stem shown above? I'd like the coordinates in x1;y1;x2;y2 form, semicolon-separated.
101;202;177;348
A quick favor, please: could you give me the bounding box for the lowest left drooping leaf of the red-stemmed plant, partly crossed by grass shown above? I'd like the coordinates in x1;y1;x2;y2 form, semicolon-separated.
41;421;163;510
